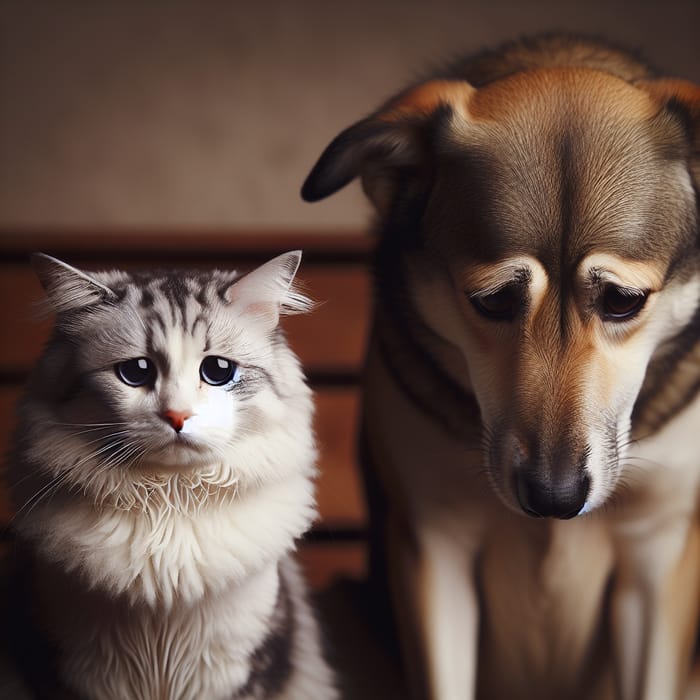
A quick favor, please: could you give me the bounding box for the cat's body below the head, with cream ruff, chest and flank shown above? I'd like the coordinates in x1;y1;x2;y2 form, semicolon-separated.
18;475;326;700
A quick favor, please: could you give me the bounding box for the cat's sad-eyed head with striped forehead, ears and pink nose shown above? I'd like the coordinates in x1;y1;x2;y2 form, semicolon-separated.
22;252;313;498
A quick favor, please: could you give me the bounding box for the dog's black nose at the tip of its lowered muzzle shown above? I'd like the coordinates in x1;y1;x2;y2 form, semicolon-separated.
515;472;591;520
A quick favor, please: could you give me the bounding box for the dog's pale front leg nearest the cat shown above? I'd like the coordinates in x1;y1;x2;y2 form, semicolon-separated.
417;529;479;700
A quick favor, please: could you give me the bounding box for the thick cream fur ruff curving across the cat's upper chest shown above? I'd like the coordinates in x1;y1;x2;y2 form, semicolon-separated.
25;473;315;609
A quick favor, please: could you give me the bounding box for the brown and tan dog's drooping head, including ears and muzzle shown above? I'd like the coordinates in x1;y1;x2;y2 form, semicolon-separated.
302;63;700;517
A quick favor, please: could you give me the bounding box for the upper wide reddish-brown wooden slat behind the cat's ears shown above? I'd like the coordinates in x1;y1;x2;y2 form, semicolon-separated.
0;260;370;374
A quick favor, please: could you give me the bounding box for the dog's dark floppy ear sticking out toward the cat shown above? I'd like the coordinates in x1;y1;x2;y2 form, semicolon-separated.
301;80;474;213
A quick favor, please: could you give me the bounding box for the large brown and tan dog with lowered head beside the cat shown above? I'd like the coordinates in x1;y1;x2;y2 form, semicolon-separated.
302;35;700;700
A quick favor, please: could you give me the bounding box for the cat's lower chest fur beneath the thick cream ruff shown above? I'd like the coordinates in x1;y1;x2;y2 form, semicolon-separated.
35;562;298;700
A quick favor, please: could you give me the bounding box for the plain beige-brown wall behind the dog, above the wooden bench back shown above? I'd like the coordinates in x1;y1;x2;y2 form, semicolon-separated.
0;0;700;229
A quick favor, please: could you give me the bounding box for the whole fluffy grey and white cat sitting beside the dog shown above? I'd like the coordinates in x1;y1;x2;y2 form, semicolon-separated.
9;251;337;700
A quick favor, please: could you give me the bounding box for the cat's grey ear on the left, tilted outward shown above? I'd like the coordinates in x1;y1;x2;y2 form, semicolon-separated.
31;253;117;313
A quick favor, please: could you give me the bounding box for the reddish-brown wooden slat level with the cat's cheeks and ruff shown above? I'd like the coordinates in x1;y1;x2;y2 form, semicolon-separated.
0;385;365;528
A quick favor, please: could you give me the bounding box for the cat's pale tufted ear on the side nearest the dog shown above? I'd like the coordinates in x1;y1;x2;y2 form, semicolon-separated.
226;250;313;328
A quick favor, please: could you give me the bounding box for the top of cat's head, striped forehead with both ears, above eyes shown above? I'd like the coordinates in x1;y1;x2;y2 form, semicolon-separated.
37;251;313;372
